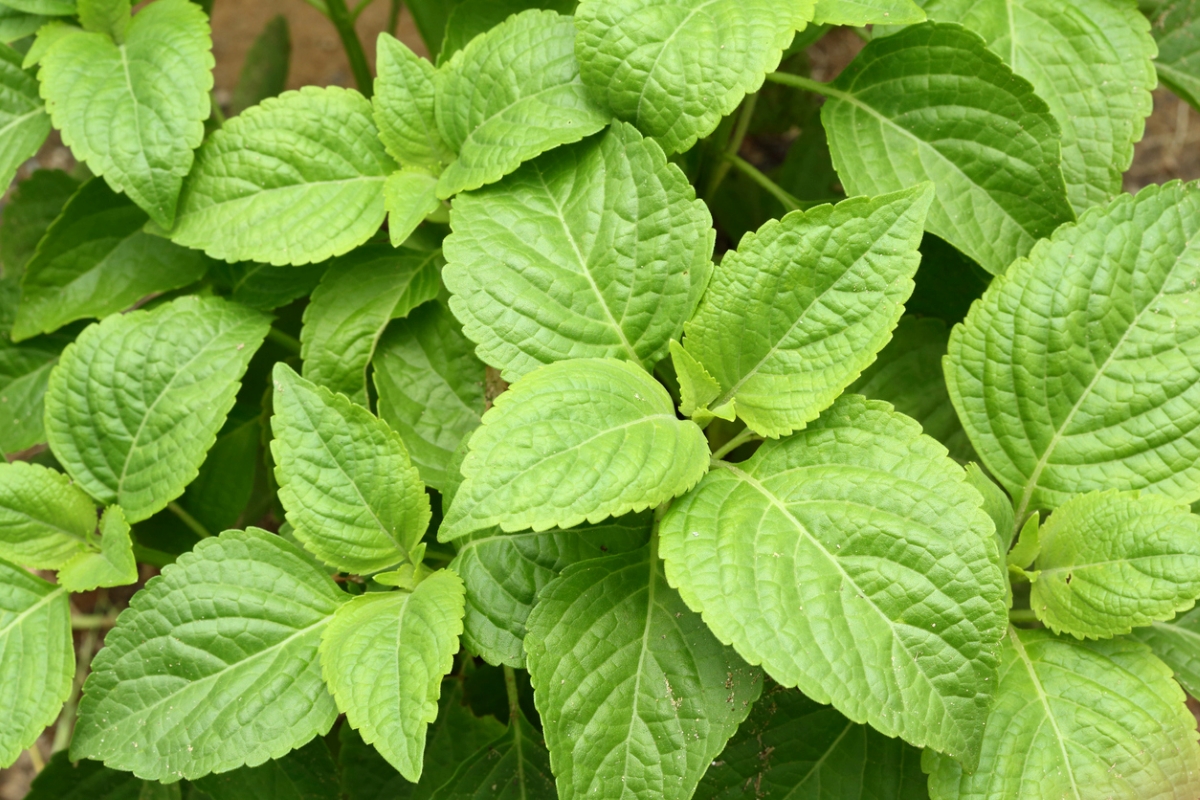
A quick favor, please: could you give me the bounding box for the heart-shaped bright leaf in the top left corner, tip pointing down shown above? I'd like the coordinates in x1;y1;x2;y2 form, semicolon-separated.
38;0;214;229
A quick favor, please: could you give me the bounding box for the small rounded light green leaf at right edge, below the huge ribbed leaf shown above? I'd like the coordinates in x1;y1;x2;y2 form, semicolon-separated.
1019;491;1200;639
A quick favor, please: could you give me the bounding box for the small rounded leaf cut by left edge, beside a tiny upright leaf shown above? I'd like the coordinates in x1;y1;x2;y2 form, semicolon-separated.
0;461;96;570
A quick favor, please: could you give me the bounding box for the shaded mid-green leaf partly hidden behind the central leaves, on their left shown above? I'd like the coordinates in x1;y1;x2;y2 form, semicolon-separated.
371;302;485;492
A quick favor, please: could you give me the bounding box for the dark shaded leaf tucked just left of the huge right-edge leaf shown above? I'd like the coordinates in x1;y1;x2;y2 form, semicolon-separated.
846;317;979;462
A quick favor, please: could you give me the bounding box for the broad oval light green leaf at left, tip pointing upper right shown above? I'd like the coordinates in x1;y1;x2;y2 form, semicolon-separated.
46;296;270;523
